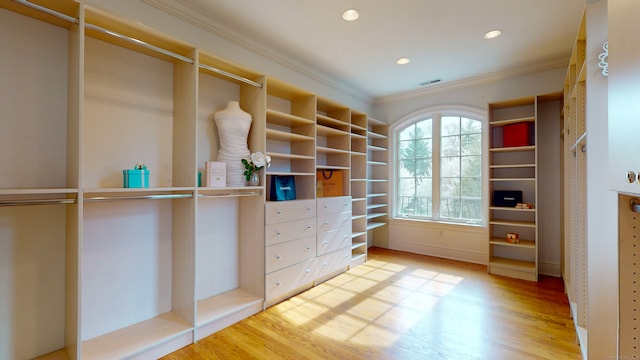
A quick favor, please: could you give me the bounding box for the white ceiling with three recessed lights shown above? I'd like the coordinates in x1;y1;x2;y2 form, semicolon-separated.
145;0;586;99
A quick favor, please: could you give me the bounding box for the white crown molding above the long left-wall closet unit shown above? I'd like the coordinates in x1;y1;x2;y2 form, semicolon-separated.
143;0;373;104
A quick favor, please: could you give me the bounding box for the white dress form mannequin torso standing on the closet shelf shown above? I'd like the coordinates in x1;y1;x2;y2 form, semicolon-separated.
214;101;251;186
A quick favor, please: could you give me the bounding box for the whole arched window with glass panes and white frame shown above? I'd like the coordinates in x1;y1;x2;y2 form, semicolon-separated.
392;109;486;224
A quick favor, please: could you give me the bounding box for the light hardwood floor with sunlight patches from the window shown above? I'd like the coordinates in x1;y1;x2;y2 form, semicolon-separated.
164;248;581;360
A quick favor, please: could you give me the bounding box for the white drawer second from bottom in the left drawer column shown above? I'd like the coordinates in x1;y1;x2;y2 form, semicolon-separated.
264;237;316;273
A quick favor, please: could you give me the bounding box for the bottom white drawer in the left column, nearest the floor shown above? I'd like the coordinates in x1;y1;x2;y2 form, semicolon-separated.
265;258;317;301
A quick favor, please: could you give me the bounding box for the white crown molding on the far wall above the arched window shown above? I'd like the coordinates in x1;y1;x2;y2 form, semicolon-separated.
373;58;569;105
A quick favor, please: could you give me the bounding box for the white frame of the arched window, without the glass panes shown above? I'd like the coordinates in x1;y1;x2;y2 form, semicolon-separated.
389;105;489;226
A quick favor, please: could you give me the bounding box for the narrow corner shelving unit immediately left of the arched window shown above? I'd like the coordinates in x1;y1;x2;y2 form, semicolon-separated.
366;118;389;247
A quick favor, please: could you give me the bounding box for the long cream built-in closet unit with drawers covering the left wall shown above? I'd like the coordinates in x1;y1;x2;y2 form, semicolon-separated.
0;0;380;359
